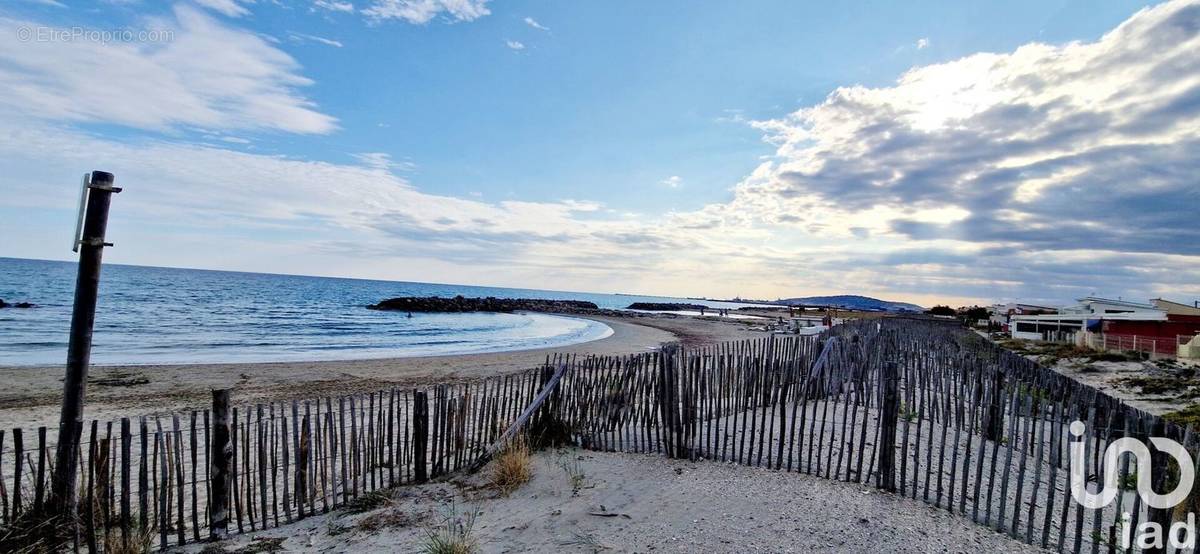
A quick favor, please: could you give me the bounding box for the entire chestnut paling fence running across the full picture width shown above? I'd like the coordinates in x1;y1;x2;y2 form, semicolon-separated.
0;319;1200;552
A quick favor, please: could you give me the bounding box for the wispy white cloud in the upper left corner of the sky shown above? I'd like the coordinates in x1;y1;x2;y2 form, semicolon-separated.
0;5;336;133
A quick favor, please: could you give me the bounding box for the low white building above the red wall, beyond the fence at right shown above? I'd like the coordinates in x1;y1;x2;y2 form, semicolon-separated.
1009;296;1166;341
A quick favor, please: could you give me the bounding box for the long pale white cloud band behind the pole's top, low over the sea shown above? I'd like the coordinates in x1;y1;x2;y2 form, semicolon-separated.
0;120;691;290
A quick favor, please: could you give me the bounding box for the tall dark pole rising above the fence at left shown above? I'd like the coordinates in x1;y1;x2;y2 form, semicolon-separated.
50;171;121;520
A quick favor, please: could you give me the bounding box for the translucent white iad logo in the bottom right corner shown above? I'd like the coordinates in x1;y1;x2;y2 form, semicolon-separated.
1070;421;1195;548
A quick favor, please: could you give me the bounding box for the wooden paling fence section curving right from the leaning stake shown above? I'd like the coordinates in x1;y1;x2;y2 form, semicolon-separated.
550;320;1200;553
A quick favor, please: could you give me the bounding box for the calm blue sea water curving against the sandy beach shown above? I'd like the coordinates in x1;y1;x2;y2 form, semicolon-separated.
0;258;758;366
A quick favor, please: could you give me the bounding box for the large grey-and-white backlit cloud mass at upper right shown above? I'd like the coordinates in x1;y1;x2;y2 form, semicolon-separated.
753;2;1200;261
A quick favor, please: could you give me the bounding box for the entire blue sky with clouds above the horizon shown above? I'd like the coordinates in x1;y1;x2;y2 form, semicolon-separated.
0;0;1200;306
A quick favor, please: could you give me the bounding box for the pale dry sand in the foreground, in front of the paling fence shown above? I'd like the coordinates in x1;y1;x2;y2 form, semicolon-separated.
187;450;1038;553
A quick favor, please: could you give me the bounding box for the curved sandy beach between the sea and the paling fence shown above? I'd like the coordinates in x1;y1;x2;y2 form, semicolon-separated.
0;314;763;428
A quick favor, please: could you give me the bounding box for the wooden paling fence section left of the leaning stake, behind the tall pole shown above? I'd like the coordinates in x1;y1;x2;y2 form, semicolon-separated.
0;357;565;552
